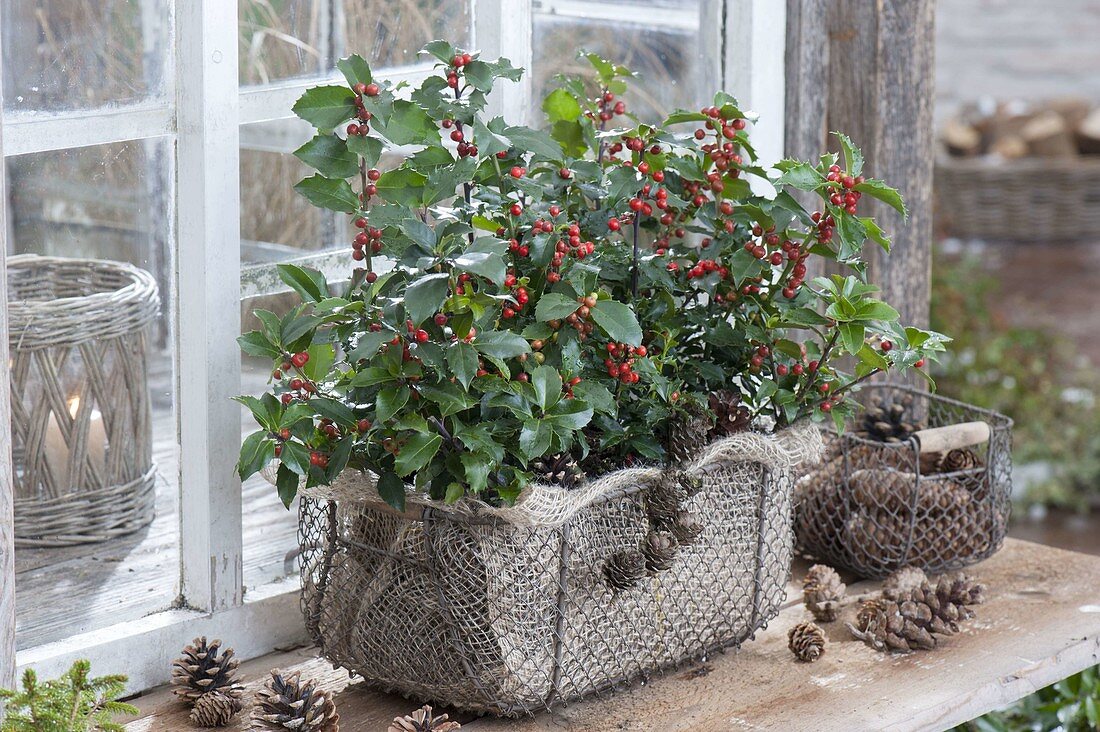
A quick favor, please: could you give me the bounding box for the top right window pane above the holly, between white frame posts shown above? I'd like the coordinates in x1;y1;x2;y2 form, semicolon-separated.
532;5;714;121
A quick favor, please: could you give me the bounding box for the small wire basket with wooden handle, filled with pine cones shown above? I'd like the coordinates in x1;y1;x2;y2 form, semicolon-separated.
794;384;1012;578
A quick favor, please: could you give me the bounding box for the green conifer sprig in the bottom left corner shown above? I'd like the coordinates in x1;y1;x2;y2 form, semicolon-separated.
0;660;139;732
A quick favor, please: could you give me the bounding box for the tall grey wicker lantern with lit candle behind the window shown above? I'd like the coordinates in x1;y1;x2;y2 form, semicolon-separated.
8;255;158;546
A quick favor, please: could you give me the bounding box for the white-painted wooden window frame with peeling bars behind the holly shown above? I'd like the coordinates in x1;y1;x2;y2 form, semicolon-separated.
0;0;785;690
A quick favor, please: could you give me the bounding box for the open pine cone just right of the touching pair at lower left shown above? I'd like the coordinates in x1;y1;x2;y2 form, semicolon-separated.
252;669;340;732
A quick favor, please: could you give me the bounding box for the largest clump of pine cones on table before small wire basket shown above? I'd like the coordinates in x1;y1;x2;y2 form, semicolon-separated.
848;576;982;653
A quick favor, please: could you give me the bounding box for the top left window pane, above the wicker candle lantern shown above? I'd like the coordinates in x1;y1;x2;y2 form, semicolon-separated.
0;0;173;111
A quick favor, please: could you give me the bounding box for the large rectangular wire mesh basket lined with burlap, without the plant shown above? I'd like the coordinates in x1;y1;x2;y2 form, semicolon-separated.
299;427;821;715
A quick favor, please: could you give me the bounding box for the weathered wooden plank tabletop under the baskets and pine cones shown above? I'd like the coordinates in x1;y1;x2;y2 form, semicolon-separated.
127;539;1100;732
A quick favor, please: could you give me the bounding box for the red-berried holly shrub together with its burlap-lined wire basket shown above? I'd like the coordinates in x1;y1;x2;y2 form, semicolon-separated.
240;41;945;714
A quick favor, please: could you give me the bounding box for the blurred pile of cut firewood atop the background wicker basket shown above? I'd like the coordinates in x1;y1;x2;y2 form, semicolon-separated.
939;98;1100;160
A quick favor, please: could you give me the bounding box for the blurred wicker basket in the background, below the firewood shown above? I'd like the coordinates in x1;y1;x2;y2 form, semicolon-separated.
934;153;1100;242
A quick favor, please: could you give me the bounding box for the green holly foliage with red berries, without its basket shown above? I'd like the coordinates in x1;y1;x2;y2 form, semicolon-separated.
239;41;948;510
